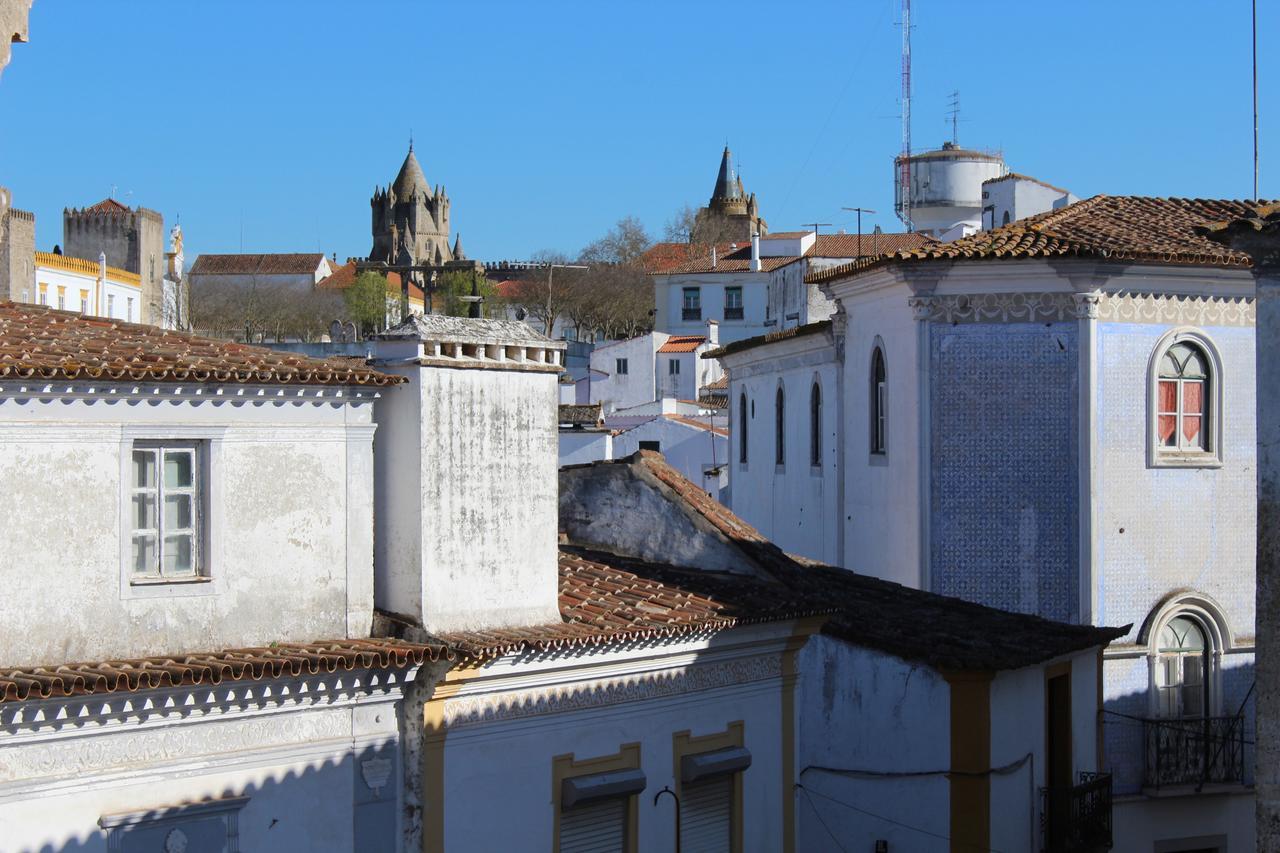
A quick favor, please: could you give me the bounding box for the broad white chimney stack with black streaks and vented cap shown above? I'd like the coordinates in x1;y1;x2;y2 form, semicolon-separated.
372;314;564;634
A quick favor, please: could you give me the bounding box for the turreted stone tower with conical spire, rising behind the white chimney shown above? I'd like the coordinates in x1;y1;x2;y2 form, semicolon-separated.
369;142;453;264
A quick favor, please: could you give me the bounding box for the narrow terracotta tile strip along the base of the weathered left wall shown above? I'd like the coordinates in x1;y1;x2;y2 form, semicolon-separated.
0;639;453;702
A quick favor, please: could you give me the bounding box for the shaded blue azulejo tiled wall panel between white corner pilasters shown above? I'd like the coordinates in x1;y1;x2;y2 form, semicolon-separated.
929;321;1079;621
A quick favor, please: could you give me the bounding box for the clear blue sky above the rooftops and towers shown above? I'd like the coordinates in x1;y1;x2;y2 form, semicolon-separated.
0;0;1280;264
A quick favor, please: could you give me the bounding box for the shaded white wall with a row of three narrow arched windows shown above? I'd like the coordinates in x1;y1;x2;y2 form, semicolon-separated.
726;334;844;570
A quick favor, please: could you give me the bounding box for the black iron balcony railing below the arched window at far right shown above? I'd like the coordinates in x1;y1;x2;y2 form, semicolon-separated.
1142;716;1244;789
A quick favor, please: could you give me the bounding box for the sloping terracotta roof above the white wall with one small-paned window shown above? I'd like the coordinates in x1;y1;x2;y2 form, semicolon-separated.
0;301;403;386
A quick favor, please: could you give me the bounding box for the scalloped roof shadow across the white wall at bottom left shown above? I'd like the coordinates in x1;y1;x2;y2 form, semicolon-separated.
15;742;401;853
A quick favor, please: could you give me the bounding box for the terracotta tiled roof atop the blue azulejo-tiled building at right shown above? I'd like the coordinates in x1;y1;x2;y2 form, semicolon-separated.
806;196;1267;283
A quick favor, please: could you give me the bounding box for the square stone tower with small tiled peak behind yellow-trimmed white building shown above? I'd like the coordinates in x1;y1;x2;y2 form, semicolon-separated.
63;199;165;325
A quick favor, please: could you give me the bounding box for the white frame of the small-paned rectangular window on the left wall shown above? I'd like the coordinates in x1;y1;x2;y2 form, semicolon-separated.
119;425;224;599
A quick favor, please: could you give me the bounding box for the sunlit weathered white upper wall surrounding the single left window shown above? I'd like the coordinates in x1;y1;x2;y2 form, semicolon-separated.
0;382;372;666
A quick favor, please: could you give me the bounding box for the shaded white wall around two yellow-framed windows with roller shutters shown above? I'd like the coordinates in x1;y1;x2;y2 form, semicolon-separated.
443;625;793;853
